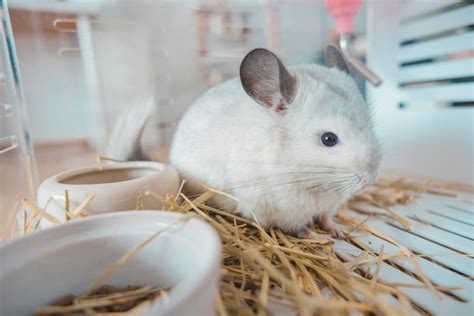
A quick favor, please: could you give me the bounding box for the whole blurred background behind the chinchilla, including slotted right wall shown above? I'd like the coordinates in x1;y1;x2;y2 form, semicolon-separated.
0;0;474;235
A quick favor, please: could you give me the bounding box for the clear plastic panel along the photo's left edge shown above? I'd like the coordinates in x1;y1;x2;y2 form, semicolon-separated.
0;0;37;239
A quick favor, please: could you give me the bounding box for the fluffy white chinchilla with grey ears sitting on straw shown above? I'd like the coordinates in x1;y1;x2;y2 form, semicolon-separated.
106;46;381;237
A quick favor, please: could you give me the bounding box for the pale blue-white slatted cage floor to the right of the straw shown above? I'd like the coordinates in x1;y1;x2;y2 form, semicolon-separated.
334;192;474;315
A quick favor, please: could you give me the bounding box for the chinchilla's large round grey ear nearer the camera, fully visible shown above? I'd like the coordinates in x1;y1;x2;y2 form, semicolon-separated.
240;48;296;112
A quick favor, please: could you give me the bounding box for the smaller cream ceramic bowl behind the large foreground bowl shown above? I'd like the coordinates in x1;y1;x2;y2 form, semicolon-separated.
38;161;180;227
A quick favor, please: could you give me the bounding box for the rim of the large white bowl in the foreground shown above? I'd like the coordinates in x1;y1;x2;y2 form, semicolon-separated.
0;210;221;311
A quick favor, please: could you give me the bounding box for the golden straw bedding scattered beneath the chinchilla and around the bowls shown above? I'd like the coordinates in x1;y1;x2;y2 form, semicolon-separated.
3;173;470;315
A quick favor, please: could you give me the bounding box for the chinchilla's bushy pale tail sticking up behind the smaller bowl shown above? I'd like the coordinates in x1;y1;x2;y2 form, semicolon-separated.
104;97;153;161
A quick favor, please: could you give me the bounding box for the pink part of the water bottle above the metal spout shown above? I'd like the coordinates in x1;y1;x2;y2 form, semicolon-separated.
326;0;362;34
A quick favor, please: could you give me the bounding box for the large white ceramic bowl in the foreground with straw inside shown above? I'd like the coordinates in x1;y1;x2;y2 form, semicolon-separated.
0;211;220;316
